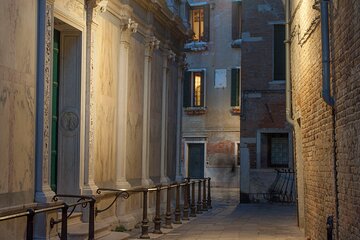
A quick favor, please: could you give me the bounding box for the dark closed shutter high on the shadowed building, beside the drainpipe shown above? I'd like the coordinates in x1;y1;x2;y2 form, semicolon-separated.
274;24;285;80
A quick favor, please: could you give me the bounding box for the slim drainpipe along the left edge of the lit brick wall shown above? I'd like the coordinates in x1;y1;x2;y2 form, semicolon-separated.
285;0;294;127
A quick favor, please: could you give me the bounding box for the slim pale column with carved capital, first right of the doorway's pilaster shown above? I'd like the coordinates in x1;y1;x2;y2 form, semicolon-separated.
116;18;137;189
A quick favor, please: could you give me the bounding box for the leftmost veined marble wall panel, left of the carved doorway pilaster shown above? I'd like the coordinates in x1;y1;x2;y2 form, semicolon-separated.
0;0;37;209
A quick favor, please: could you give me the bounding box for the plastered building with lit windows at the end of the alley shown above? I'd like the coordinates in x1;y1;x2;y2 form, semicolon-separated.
181;1;241;189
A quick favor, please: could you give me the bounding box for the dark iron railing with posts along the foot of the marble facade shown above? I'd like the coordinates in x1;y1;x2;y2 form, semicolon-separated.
0;178;212;240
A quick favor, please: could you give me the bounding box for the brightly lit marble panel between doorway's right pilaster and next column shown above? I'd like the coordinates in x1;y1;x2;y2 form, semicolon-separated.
95;13;120;184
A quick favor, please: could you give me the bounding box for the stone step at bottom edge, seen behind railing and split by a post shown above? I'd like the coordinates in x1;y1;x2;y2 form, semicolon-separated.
68;222;111;240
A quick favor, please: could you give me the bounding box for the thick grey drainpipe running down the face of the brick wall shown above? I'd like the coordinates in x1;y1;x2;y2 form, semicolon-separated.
320;0;334;107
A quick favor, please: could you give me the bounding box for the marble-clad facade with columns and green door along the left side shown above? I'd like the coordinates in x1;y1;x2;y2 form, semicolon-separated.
0;0;188;239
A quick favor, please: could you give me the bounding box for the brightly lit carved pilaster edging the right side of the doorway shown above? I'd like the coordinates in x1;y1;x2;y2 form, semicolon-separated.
83;0;108;194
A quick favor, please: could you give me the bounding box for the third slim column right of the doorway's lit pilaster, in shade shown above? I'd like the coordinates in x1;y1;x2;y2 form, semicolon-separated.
160;50;176;183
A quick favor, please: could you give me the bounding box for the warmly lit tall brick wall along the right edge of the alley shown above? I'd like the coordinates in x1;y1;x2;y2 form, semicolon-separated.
291;0;360;239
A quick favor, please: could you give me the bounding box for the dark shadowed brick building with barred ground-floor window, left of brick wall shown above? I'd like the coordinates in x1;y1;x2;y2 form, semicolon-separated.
240;0;293;202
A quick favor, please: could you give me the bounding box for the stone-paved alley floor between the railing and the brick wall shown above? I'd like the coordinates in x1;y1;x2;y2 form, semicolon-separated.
126;188;305;240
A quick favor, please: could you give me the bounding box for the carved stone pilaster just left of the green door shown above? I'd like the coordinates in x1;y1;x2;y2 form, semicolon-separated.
35;0;55;203
